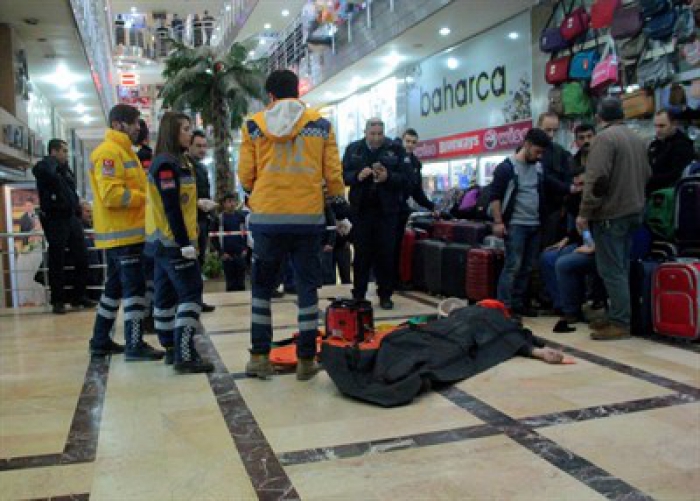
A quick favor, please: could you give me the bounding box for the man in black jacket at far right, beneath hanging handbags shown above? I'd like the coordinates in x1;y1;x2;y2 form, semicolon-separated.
646;110;695;197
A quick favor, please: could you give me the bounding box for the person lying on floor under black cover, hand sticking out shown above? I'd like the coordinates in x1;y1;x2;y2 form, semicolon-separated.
321;305;566;407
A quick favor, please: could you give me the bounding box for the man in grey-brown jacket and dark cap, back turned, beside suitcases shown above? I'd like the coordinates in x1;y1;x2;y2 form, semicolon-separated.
576;97;651;341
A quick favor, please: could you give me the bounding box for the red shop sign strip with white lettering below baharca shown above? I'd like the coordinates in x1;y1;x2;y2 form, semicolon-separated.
415;120;532;160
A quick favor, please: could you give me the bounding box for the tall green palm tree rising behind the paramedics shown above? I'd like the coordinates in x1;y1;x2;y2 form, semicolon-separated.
160;40;264;199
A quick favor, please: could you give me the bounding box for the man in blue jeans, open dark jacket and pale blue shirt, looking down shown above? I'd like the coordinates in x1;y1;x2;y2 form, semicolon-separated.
490;129;551;319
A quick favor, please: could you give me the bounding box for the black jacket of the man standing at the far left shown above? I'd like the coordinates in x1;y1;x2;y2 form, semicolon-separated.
32;156;80;219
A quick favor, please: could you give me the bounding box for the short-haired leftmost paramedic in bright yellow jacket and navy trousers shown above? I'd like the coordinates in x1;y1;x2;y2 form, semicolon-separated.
90;104;163;361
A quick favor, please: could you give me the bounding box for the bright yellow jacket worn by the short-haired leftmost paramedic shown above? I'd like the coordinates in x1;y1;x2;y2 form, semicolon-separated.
90;129;146;249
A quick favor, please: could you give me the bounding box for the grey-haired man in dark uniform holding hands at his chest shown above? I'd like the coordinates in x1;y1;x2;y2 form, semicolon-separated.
343;118;409;310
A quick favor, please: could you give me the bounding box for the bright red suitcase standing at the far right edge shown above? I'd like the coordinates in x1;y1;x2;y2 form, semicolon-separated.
652;260;700;339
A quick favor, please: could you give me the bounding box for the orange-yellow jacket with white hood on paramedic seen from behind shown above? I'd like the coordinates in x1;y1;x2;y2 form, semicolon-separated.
238;99;345;233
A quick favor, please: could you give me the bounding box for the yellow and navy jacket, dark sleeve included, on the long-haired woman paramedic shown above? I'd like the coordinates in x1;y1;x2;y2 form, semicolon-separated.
146;154;197;257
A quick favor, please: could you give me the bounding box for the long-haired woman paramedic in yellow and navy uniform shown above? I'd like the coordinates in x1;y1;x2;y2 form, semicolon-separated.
146;112;214;374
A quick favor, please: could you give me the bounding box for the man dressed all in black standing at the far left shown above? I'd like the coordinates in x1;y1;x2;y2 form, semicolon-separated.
32;139;95;315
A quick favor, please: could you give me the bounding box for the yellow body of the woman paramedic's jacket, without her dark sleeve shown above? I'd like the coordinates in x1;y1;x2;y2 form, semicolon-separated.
146;155;197;257
